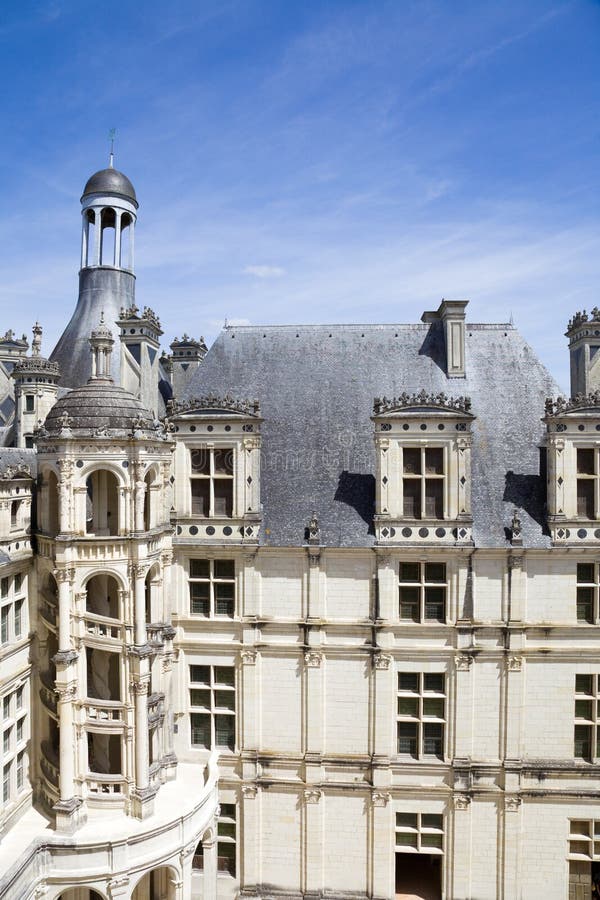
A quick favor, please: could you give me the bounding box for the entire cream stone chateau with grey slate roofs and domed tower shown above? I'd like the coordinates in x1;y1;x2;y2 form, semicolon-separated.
0;165;600;900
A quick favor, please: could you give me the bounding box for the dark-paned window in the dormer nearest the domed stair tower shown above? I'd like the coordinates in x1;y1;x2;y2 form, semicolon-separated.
190;447;234;518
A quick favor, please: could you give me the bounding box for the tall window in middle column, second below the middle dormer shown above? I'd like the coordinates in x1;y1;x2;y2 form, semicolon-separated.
397;672;446;759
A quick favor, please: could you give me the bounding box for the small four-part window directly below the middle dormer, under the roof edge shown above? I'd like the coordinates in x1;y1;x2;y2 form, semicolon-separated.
399;562;448;622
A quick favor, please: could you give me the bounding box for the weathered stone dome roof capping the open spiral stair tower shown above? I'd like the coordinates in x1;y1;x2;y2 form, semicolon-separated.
44;379;155;435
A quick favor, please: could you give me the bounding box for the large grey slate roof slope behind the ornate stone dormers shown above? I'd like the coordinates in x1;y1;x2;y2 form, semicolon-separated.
186;323;560;547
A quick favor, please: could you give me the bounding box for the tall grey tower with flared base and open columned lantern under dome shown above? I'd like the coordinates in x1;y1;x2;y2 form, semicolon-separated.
51;154;138;388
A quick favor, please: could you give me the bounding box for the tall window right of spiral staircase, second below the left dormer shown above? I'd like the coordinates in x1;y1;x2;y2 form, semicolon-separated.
190;666;235;750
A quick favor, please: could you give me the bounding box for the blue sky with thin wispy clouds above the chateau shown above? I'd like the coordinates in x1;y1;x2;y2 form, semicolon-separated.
0;0;600;388
